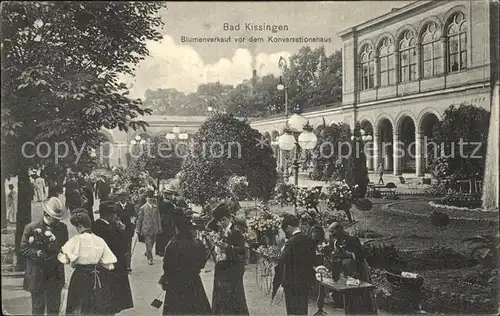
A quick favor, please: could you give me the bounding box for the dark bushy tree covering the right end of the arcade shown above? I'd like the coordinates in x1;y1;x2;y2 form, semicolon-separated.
427;104;490;188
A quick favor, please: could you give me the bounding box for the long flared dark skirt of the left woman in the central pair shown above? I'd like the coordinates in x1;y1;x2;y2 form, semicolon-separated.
163;273;212;315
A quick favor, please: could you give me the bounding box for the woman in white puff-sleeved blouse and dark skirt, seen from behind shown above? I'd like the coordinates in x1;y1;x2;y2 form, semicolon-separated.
58;209;117;315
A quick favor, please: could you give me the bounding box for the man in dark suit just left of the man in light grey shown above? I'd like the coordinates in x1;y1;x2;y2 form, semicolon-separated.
115;191;136;273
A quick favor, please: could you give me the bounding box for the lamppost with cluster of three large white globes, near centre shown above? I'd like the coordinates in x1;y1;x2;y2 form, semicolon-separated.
278;106;318;214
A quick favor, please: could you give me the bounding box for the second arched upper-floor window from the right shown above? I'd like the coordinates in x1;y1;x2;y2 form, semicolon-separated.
422;22;443;78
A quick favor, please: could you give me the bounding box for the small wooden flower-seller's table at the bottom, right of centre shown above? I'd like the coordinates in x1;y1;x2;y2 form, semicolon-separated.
314;276;375;316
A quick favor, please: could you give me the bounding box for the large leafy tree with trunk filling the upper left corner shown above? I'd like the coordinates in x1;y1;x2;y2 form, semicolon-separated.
1;2;164;267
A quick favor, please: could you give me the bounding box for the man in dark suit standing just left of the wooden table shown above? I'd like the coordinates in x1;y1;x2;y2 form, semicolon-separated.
279;214;316;315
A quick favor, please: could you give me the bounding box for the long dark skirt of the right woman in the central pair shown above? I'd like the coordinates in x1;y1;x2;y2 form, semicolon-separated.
212;262;249;315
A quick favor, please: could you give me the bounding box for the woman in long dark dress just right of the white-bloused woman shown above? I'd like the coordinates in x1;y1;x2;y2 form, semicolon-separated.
92;201;134;313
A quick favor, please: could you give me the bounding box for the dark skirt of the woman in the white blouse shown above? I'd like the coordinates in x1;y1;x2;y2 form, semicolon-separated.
66;265;110;315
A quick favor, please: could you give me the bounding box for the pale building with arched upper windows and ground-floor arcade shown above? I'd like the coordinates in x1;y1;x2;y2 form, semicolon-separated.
103;0;499;176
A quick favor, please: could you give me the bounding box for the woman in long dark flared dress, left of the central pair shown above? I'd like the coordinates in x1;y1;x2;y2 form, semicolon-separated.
159;210;212;315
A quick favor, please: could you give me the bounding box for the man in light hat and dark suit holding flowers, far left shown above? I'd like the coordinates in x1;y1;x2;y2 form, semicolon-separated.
19;197;68;315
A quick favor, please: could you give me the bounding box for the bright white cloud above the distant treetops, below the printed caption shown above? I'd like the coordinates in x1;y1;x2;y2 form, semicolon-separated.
124;35;291;98
